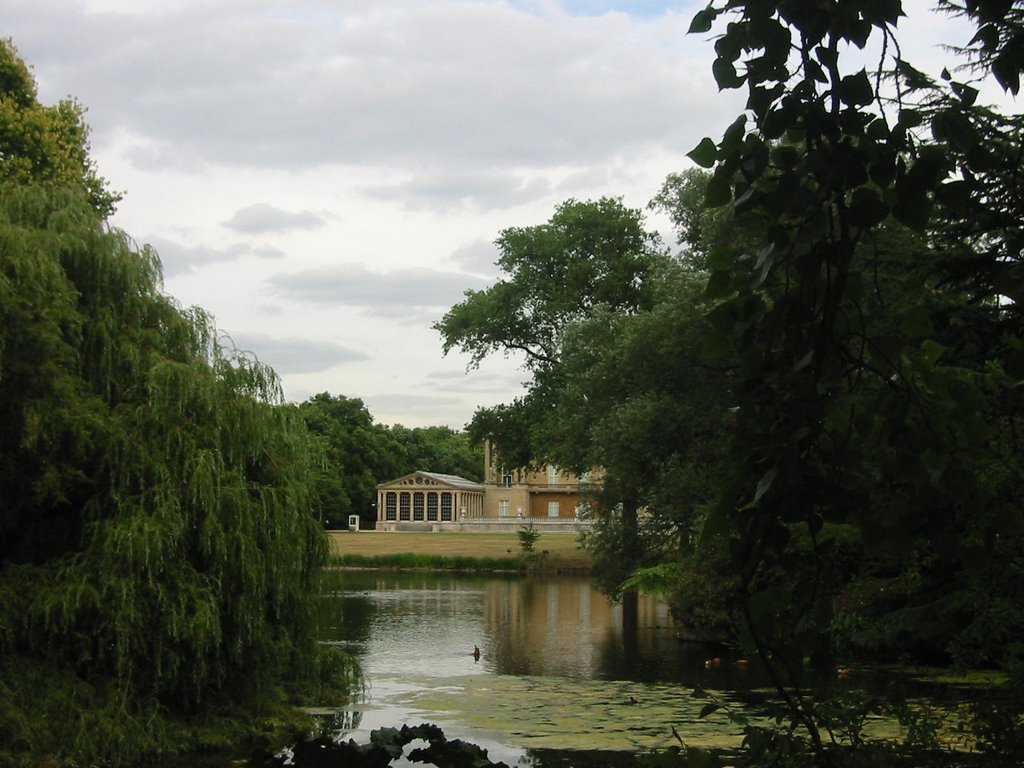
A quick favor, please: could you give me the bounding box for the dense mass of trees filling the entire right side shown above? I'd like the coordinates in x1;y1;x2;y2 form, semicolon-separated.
437;0;1024;765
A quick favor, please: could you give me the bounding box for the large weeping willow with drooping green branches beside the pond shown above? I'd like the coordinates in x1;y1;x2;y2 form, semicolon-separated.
0;43;351;763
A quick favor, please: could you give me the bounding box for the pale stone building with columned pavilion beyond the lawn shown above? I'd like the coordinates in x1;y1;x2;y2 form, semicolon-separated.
377;443;594;530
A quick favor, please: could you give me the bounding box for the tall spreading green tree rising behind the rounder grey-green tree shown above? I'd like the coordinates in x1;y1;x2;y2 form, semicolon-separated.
435;198;665;581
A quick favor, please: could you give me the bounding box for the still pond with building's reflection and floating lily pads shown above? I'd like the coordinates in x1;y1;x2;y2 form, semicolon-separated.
321;571;794;766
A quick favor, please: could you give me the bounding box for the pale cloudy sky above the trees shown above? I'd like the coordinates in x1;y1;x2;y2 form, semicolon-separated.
0;0;987;429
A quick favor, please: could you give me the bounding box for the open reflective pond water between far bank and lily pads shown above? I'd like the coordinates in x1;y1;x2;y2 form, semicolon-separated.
321;571;707;682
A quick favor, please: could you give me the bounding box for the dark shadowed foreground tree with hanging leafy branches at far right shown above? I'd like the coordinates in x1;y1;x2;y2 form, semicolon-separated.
690;0;1024;760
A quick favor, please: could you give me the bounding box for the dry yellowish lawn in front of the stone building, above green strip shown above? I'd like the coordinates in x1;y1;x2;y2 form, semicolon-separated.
328;530;591;568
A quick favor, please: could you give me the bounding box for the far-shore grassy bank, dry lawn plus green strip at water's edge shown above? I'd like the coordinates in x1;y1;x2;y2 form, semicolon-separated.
328;530;591;571
